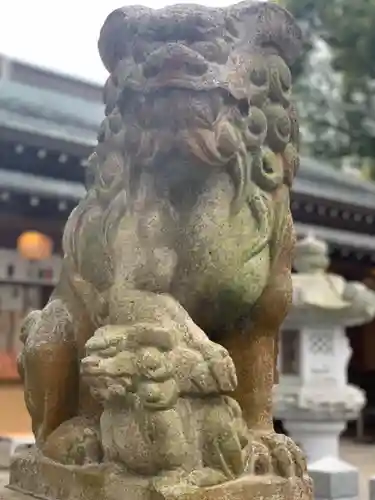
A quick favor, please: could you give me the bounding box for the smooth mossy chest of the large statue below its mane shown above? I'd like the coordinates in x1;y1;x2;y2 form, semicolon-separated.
113;173;269;318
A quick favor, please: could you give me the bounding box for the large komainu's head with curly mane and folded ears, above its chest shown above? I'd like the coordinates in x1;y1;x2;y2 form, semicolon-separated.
88;2;301;229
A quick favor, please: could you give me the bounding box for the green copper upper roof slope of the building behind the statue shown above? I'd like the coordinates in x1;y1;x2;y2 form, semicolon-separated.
0;79;375;209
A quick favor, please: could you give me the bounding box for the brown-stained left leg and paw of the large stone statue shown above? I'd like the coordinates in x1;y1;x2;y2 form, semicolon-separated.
19;278;101;463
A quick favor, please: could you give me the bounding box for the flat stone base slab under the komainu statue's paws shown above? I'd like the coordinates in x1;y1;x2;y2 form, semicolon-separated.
7;450;313;500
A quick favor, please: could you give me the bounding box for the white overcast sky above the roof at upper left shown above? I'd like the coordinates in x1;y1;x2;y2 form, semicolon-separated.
0;0;241;82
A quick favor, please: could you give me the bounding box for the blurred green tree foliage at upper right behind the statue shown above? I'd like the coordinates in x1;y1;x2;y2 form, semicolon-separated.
282;0;375;177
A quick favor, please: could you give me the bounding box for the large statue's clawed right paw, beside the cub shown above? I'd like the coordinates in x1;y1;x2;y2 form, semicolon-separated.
249;432;307;478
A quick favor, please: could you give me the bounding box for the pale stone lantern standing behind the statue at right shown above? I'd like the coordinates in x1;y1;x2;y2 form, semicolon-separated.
274;235;375;463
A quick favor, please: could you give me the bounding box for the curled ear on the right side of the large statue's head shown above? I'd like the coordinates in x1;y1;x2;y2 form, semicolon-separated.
227;0;302;66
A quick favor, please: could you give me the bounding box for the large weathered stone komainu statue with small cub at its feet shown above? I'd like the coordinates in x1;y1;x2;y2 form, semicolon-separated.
11;2;312;498
